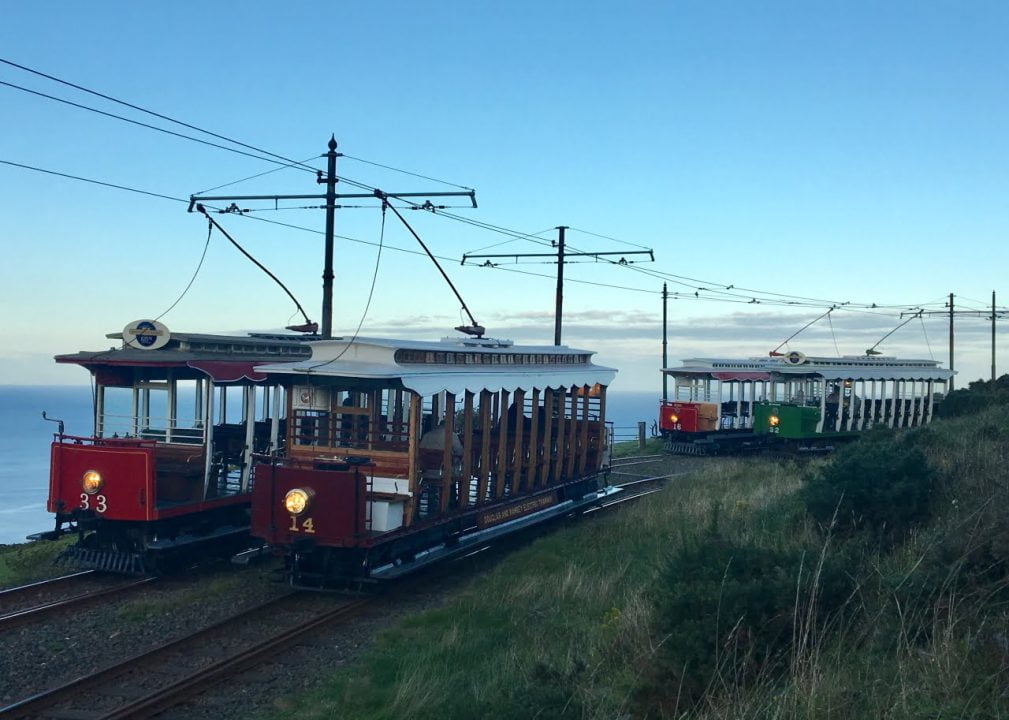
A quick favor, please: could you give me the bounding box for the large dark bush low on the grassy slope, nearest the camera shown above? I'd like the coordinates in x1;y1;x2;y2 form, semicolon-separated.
651;531;853;710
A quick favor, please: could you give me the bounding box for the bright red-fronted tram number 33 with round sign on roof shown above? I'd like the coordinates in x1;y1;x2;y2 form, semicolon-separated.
41;323;311;573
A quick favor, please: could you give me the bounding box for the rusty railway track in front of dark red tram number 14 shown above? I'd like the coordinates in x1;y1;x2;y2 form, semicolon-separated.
0;592;374;720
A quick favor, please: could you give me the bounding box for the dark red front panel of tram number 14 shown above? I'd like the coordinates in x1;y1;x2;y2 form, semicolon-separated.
251;465;367;548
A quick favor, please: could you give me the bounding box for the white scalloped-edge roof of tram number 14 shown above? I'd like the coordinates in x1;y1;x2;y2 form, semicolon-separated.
256;337;616;395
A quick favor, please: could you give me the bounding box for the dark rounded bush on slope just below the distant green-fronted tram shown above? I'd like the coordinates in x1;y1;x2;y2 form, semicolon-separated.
800;432;935;539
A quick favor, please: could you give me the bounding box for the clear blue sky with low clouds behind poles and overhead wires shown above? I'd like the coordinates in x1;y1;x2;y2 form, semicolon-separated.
0;0;1009;390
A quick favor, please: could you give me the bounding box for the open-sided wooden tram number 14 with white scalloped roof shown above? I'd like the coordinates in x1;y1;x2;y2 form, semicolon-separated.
252;338;615;587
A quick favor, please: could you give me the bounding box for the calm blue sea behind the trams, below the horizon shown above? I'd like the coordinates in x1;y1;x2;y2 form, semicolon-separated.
0;385;660;544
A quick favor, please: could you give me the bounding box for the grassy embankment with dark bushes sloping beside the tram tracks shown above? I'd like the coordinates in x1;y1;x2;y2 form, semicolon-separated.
262;387;1009;720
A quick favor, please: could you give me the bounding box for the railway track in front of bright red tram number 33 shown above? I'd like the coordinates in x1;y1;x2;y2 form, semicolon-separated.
0;570;156;631
